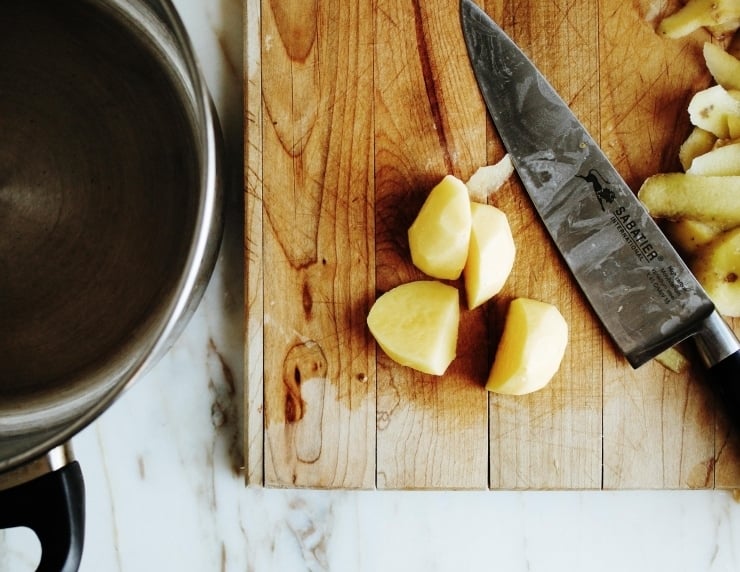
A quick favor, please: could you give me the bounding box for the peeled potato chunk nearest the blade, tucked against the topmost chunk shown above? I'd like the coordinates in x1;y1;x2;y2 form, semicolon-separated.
463;203;516;310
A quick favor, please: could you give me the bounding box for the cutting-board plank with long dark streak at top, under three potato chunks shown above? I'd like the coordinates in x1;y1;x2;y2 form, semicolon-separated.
375;0;488;489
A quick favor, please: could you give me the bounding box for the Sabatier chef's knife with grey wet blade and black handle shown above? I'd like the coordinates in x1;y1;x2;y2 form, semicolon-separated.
460;0;740;423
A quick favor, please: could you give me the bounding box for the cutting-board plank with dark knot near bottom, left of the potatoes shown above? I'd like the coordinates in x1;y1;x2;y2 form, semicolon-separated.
261;0;375;488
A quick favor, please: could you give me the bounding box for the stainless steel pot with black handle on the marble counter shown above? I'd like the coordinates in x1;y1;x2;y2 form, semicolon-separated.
0;0;222;570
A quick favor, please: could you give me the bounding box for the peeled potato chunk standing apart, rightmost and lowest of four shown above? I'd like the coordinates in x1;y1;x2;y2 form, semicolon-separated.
486;298;568;395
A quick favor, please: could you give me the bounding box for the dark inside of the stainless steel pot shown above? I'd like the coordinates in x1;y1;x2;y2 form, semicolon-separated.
0;0;200;431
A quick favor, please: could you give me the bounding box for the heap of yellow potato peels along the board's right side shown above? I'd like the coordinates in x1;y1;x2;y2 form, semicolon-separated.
638;17;740;373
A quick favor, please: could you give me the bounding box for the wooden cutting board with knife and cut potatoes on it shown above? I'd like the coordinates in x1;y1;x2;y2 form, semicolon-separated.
245;0;740;489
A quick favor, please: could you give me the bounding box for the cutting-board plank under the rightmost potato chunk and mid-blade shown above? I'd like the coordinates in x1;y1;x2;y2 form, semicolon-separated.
482;0;604;489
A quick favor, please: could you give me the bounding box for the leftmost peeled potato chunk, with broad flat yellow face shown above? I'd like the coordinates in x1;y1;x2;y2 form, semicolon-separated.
367;280;460;375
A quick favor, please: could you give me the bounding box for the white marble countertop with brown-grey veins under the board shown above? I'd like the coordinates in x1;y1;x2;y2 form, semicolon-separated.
0;0;740;572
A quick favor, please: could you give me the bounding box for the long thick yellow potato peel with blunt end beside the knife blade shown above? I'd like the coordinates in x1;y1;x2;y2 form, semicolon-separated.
637;173;740;229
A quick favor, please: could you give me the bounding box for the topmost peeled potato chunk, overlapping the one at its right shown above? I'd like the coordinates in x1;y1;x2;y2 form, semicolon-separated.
408;175;471;280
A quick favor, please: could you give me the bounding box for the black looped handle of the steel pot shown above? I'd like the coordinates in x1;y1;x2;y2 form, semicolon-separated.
0;461;85;572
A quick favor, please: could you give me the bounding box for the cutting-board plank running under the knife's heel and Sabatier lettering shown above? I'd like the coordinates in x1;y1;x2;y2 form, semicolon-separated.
598;1;736;489
